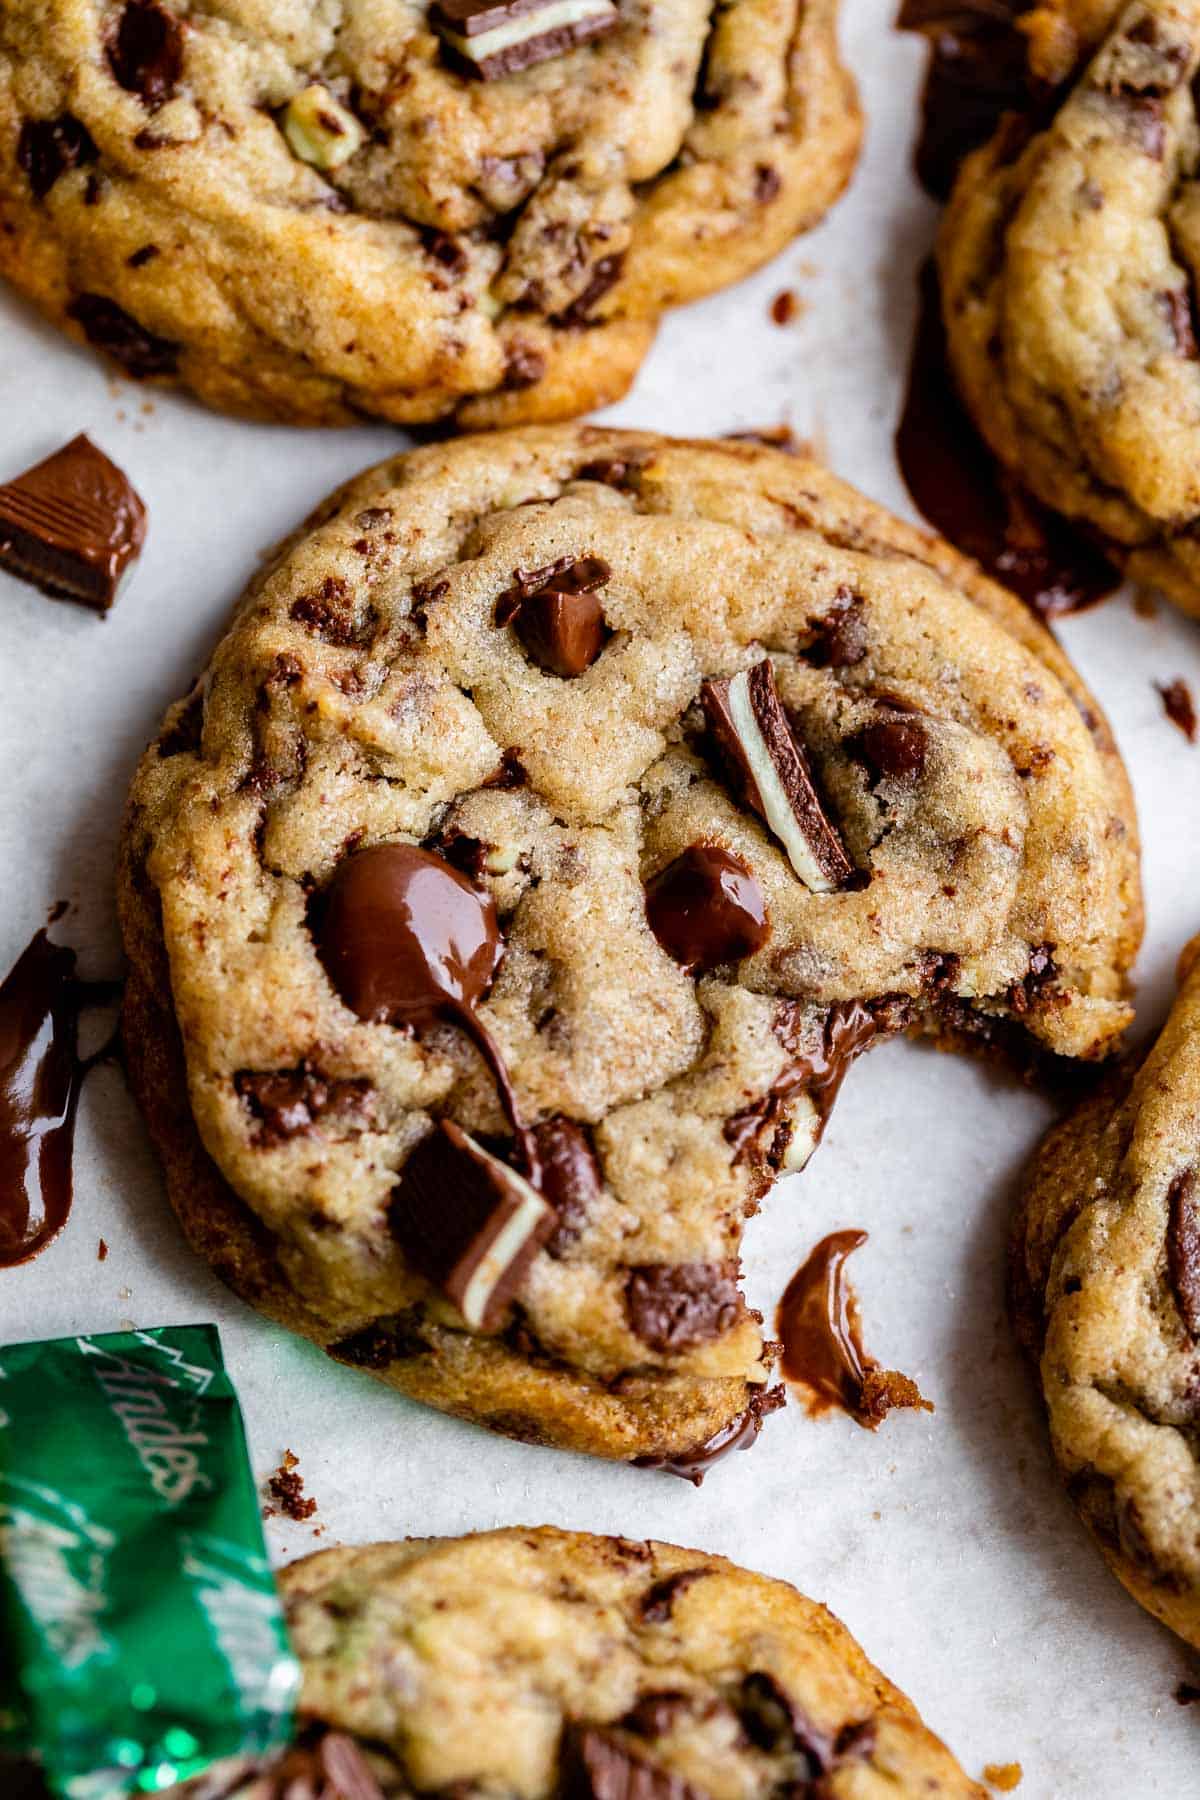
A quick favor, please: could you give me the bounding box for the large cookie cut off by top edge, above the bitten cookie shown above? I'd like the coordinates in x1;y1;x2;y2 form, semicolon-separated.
0;0;860;425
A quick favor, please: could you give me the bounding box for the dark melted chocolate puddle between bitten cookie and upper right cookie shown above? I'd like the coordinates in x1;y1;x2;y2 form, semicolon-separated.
896;261;1123;619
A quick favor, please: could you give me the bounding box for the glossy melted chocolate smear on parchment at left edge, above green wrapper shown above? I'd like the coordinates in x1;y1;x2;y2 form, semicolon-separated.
0;914;121;1269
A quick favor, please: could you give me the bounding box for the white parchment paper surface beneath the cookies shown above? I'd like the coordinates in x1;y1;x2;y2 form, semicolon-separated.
0;0;1200;1800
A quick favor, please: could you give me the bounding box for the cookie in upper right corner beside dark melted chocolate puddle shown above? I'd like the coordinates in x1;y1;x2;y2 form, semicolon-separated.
937;0;1200;612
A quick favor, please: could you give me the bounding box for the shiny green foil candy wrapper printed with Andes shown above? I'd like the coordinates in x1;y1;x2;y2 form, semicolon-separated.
0;1325;300;1800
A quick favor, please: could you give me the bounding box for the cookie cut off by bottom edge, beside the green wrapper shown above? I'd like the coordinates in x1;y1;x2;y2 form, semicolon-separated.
189;1526;984;1800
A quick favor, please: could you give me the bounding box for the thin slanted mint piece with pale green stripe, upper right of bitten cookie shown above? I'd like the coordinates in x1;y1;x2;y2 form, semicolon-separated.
700;657;855;895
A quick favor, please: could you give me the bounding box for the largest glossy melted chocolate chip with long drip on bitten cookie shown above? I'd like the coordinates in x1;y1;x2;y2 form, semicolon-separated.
315;844;538;1170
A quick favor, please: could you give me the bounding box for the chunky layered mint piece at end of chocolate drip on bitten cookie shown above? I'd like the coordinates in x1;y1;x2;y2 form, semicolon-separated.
389;1120;556;1332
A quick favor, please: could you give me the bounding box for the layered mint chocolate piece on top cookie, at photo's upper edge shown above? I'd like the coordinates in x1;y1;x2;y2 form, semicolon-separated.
430;0;619;81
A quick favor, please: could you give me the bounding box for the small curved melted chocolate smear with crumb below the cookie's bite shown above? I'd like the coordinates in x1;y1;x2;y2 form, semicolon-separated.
775;1231;934;1431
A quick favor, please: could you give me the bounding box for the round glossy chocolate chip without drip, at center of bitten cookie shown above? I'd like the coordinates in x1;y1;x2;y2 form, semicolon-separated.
646;844;770;974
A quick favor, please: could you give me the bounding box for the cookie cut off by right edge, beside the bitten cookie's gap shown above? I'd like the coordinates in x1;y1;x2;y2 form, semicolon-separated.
1011;938;1200;1647
